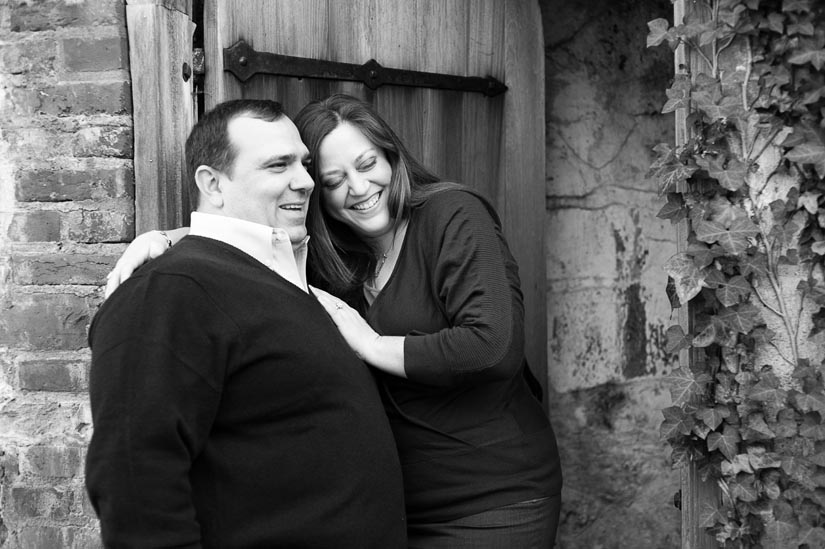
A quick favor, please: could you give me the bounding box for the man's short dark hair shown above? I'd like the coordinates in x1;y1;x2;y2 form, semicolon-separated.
186;99;284;210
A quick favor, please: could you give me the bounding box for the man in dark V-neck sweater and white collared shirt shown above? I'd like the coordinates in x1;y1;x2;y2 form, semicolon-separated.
86;100;406;549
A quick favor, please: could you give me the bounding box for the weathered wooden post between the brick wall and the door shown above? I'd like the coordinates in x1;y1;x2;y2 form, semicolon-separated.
126;0;195;234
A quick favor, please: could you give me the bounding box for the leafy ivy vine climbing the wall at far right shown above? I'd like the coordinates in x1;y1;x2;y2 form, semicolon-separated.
647;0;825;548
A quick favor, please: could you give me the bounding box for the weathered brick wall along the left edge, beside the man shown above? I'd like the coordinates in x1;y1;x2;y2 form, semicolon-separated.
0;0;134;549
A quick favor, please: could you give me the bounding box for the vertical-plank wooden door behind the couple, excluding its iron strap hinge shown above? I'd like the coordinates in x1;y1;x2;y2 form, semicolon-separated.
204;0;546;392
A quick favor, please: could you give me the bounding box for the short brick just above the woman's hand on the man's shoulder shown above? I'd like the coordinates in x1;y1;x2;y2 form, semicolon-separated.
65;199;135;243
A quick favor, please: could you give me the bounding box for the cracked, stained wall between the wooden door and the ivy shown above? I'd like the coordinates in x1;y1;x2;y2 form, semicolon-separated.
541;0;680;549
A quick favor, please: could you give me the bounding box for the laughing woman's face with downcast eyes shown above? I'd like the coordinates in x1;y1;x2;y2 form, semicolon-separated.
318;122;393;240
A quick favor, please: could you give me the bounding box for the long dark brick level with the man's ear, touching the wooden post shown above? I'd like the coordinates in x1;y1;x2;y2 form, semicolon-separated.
15;167;134;202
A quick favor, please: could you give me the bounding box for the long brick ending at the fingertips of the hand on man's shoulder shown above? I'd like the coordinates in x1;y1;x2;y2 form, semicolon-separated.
12;253;118;286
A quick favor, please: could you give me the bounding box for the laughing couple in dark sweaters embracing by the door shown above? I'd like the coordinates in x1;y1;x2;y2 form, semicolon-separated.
87;95;561;548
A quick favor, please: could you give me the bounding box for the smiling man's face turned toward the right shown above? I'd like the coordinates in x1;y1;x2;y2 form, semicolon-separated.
220;116;315;244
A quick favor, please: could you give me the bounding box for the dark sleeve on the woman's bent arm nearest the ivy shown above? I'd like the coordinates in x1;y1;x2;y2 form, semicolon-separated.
404;192;524;386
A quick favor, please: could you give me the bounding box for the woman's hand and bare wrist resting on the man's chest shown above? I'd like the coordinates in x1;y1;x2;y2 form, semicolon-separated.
310;286;407;377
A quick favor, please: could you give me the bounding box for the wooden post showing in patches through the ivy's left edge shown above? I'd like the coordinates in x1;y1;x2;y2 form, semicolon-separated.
673;0;720;549
